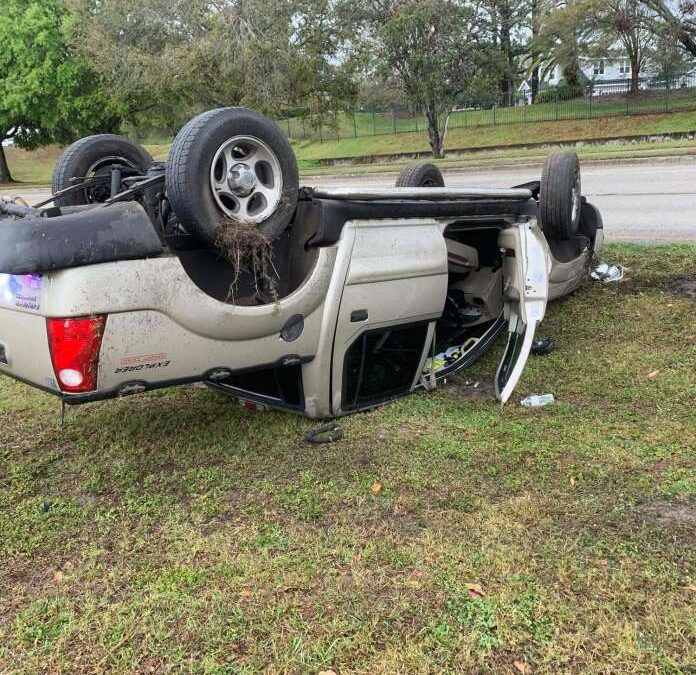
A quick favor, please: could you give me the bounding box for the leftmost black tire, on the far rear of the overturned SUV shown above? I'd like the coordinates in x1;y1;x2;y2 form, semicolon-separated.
51;134;153;206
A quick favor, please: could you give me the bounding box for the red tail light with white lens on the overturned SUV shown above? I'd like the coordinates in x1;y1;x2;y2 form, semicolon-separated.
46;316;106;394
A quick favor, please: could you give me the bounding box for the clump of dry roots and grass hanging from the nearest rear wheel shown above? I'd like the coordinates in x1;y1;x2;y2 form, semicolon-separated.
215;218;279;302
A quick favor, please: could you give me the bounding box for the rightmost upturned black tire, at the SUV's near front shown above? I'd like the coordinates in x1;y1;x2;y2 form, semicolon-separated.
539;152;582;239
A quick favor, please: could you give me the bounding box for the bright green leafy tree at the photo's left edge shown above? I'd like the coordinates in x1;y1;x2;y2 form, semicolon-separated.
0;0;118;182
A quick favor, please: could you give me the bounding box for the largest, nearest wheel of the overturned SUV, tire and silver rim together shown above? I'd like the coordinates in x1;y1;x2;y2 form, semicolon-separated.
166;108;299;244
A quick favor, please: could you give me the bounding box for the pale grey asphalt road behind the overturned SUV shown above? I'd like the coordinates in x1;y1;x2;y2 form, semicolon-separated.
0;160;696;243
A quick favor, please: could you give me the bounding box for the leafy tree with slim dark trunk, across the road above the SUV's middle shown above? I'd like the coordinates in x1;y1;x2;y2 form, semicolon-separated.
367;0;479;157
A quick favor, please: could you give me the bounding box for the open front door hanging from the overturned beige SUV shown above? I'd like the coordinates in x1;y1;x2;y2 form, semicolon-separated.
495;221;551;404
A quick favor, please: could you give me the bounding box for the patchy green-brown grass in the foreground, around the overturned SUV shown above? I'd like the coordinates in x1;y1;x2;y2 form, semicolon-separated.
0;246;696;675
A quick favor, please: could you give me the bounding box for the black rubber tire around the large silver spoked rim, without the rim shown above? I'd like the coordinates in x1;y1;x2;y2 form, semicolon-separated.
167;108;300;244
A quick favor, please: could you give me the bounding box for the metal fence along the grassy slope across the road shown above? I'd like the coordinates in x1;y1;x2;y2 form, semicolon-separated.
277;74;696;141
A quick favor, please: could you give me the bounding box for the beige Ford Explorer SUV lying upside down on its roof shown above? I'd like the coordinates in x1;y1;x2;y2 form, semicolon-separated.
0;108;603;418
